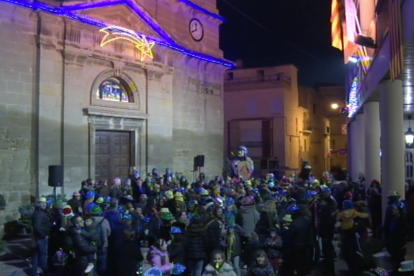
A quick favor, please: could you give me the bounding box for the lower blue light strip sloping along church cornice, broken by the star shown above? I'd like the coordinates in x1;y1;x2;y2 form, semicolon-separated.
0;0;234;67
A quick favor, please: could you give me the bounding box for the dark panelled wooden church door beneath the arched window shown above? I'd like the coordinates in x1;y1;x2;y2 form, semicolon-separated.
95;130;131;183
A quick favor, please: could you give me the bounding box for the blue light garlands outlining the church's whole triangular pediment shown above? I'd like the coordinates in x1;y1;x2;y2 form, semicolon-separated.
0;0;234;68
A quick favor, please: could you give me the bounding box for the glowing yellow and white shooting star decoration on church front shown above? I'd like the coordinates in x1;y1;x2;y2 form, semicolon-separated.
99;26;155;61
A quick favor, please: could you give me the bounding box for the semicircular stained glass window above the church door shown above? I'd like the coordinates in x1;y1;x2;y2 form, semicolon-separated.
96;78;130;102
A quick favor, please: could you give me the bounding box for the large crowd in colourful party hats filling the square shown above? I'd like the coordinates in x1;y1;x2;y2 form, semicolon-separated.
29;169;408;276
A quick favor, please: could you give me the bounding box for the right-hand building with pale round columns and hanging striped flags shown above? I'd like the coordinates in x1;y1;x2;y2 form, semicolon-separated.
332;0;414;205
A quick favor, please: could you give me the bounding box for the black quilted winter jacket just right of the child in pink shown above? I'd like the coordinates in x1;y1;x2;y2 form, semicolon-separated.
185;224;209;261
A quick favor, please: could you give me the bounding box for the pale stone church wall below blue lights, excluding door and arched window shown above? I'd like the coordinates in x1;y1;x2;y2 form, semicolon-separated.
0;2;225;233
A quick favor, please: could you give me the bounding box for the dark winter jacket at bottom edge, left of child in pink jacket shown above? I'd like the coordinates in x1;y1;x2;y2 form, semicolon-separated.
114;241;144;276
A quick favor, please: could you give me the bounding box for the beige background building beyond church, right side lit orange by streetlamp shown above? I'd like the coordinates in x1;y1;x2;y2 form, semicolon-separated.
224;65;340;177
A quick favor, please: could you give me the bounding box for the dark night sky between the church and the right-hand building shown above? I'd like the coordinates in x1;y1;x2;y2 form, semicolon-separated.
217;0;345;86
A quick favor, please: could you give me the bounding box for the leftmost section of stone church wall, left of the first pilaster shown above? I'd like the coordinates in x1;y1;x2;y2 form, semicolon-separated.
0;3;36;232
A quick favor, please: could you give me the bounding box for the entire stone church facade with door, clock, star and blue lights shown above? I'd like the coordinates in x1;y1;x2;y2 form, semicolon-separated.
0;0;233;205
